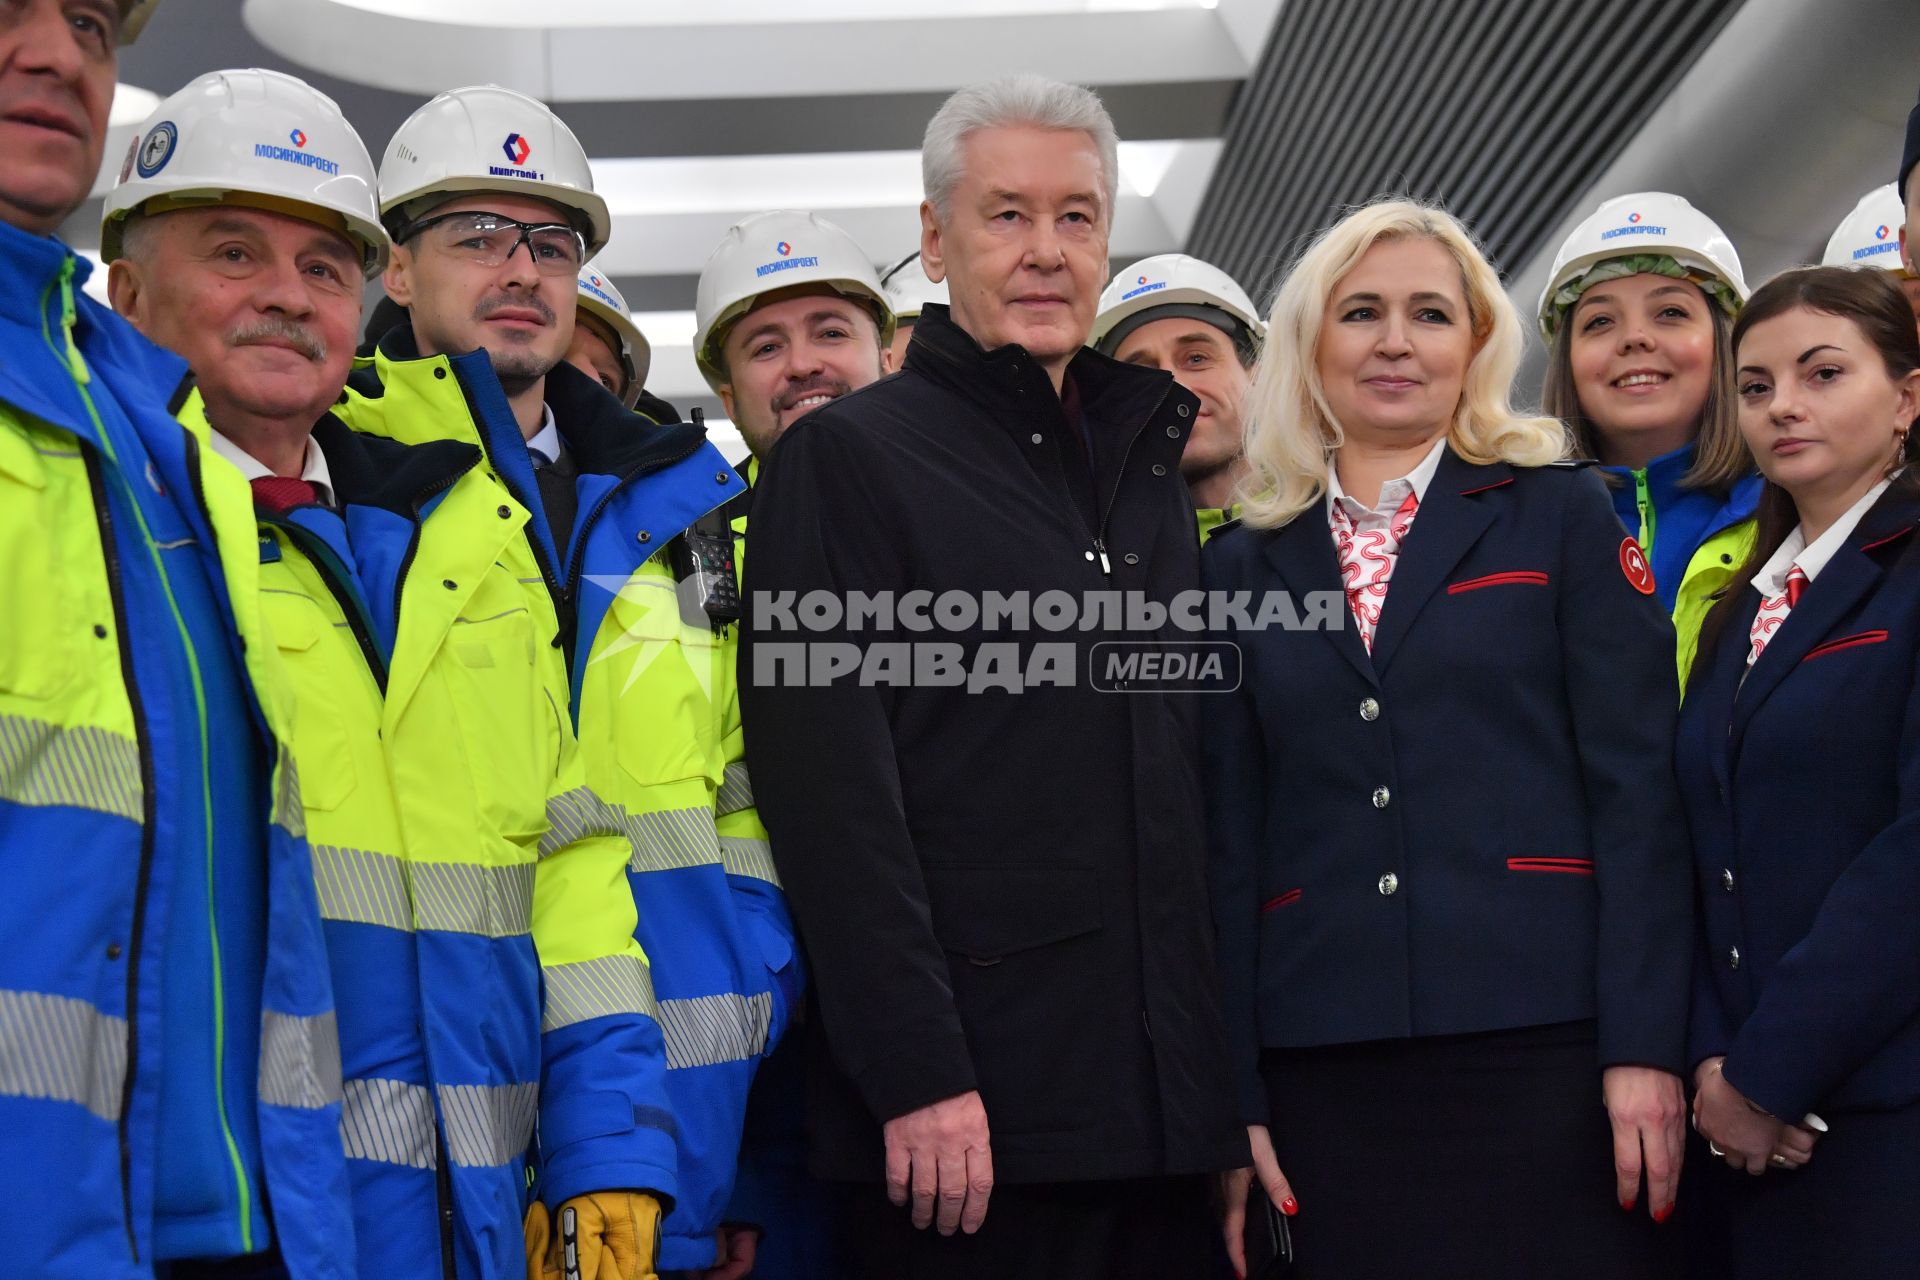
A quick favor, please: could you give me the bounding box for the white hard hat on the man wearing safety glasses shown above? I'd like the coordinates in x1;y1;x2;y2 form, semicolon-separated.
380;84;612;257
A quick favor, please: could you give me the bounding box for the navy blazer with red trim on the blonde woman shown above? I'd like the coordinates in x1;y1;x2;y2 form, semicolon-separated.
1202;451;1692;1121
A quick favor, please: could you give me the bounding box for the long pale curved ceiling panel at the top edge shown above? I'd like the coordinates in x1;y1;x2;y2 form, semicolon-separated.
244;0;1248;104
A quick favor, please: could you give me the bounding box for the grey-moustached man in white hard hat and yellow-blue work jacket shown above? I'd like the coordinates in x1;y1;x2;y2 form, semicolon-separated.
100;71;668;1280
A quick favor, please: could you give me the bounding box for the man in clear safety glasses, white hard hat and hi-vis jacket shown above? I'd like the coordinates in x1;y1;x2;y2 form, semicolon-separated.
357;86;783;1274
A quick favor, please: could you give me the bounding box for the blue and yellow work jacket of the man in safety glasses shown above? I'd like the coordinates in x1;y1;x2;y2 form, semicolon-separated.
342;328;797;1270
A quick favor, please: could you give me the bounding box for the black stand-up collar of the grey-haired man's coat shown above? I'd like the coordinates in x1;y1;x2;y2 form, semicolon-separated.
902;303;1200;432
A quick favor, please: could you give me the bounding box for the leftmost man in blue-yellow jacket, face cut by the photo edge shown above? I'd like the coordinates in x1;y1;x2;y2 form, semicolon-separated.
0;10;353;1280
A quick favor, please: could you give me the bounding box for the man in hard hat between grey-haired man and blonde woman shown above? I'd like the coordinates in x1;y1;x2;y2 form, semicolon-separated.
1089;253;1267;543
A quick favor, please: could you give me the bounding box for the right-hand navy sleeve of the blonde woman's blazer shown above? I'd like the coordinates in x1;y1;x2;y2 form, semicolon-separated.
1559;472;1693;1075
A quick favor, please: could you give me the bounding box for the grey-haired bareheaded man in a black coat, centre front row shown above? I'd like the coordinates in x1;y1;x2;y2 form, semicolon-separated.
741;77;1248;1280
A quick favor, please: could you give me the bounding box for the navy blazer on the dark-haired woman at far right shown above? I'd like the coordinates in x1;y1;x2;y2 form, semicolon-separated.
1680;477;1920;1119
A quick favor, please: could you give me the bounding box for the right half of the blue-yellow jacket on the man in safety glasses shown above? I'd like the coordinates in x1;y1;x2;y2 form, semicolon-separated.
547;367;801;1270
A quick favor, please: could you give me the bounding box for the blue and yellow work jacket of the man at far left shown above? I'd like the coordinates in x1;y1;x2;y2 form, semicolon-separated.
0;226;353;1280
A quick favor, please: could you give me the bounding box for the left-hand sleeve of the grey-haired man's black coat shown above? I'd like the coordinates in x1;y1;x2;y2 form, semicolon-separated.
739;413;975;1121
